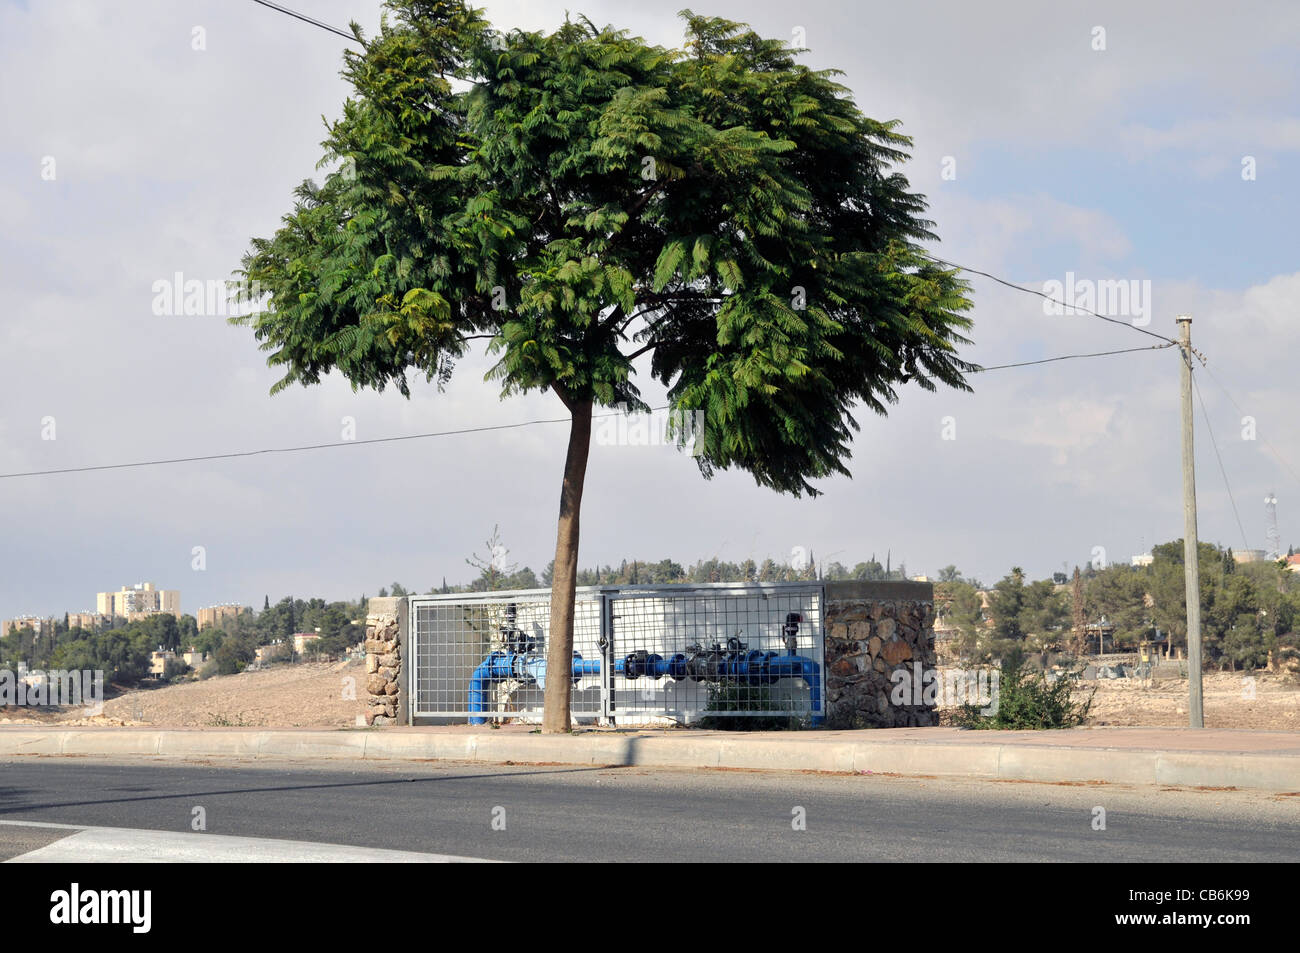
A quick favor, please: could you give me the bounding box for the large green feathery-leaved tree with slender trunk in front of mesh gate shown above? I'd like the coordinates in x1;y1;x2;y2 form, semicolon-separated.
233;0;972;732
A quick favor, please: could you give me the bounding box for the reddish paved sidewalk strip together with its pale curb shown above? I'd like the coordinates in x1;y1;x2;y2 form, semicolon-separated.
0;725;1300;793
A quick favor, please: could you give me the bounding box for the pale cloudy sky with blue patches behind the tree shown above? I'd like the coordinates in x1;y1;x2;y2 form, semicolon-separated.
0;0;1300;618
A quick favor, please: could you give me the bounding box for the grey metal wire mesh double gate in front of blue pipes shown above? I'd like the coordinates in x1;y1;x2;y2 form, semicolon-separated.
410;584;826;725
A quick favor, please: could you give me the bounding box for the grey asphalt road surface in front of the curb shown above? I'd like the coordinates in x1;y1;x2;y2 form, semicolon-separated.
0;758;1300;862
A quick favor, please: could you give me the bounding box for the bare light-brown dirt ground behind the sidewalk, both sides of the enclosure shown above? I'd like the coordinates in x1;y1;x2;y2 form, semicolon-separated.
0;662;1300;731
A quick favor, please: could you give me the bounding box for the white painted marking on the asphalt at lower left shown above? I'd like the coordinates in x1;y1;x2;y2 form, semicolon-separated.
0;820;489;863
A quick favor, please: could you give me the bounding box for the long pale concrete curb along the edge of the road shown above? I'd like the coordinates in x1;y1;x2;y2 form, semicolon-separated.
0;728;1300;792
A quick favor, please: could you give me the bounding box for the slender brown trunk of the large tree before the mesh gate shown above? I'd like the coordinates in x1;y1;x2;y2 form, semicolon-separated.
542;387;592;735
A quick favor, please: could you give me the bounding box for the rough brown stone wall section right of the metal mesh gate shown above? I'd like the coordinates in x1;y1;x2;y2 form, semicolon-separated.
826;582;939;728
